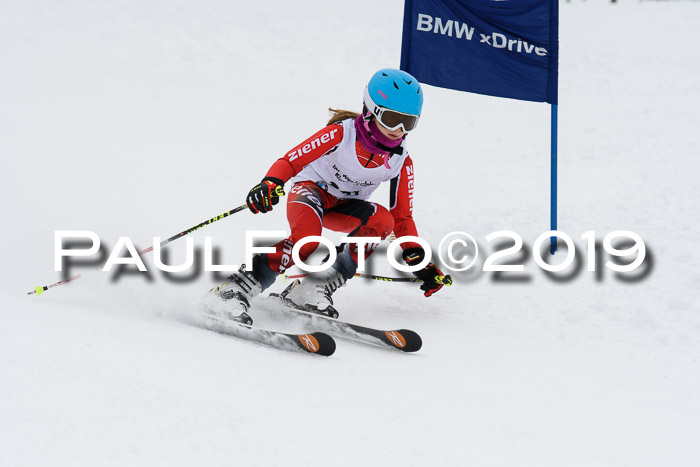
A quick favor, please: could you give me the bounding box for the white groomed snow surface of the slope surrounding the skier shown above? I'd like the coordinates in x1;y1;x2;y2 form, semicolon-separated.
0;0;700;466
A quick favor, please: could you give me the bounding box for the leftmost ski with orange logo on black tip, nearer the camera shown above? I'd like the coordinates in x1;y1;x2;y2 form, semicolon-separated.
199;308;335;357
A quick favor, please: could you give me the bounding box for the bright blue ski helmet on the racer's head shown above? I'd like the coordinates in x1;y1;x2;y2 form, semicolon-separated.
364;68;423;116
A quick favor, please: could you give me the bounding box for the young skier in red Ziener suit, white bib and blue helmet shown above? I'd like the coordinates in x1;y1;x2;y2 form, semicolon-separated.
212;69;452;324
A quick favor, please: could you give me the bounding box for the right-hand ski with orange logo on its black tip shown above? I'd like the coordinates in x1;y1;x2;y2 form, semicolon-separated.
269;285;423;352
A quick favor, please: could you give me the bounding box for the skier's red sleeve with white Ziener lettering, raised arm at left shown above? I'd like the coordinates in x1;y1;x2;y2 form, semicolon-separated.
265;124;343;182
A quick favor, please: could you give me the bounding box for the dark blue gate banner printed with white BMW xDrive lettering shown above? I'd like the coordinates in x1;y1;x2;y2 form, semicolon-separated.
401;0;559;105
